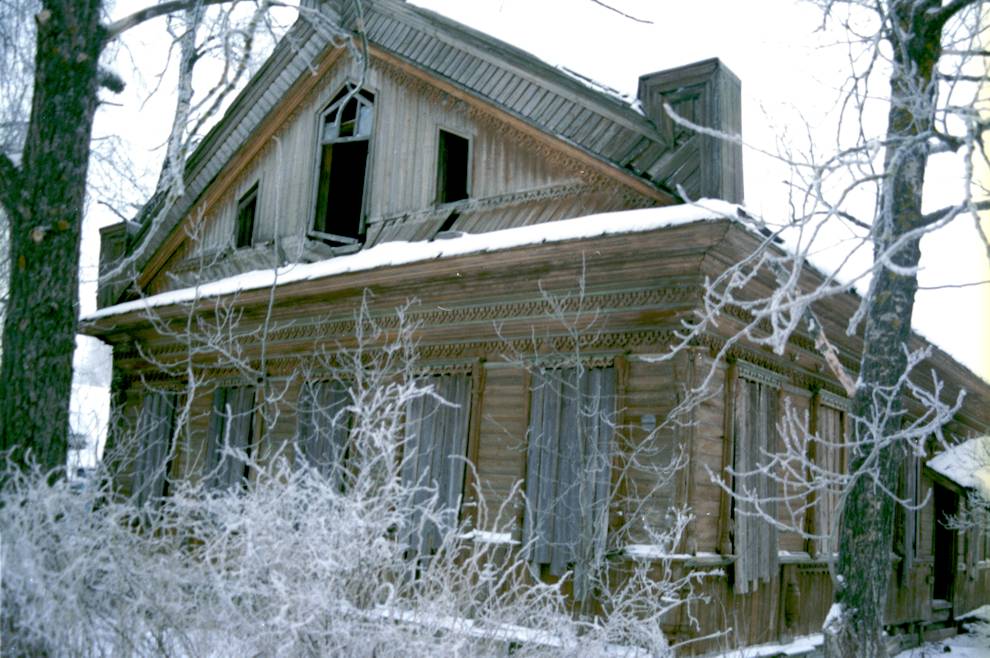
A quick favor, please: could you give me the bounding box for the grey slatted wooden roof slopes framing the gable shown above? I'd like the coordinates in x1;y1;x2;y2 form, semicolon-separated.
130;0;720;286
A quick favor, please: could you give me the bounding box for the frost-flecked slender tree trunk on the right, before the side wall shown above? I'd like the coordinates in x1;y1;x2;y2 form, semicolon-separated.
826;0;944;658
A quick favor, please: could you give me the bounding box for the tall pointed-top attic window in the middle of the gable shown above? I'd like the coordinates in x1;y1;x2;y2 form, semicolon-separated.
313;85;375;245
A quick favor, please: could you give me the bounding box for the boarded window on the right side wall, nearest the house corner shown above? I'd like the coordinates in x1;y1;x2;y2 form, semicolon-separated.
732;378;779;594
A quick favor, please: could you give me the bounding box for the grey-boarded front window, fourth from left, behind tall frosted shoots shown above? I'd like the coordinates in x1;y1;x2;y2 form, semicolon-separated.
402;373;471;555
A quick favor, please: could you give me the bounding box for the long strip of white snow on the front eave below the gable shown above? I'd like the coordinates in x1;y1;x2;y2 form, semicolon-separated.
82;199;739;321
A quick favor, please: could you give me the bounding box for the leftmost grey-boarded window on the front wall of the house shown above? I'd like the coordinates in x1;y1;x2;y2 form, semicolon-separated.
133;391;176;505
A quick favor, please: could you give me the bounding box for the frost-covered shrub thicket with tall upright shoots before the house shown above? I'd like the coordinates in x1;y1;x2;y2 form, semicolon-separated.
0;304;697;656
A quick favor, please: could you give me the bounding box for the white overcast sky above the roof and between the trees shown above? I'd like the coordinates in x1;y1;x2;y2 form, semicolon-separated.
83;0;990;379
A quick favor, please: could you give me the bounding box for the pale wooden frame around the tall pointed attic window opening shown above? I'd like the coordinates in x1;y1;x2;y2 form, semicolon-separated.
306;80;379;246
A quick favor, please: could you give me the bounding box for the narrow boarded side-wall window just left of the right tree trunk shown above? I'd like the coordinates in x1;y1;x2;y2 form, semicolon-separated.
815;401;846;558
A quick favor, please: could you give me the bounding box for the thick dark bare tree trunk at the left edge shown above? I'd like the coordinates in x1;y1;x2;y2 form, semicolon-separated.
0;0;104;469
